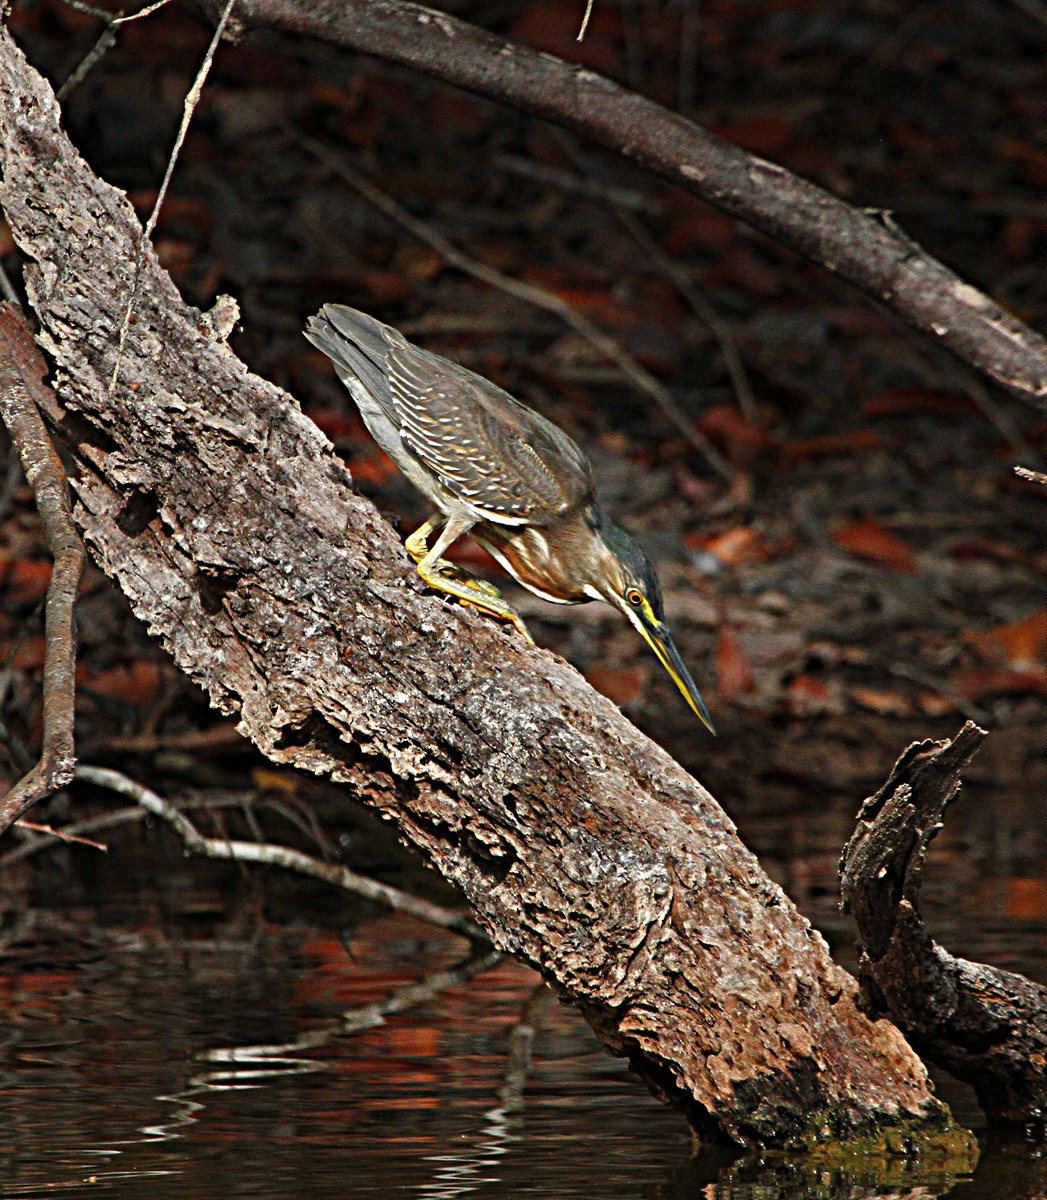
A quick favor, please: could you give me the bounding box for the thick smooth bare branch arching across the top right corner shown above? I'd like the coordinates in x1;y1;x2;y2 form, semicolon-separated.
217;0;1047;406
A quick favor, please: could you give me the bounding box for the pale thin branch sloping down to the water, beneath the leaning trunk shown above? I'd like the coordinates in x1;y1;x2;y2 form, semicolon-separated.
76;766;490;944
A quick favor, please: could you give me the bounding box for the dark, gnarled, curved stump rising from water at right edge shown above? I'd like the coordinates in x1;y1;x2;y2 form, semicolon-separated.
840;721;1047;1134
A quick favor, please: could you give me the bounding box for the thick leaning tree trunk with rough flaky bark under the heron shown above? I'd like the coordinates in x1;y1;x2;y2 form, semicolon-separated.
0;11;968;1150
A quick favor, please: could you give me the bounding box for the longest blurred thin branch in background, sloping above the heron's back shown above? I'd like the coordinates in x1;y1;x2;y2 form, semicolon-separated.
292;132;735;481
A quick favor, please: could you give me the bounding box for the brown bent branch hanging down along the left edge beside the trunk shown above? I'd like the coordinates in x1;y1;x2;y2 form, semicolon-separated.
0;304;85;833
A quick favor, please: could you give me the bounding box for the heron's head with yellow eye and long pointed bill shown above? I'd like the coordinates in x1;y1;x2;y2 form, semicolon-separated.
586;514;716;733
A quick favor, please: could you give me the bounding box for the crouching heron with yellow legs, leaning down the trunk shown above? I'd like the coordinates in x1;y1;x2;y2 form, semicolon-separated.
305;304;714;732
